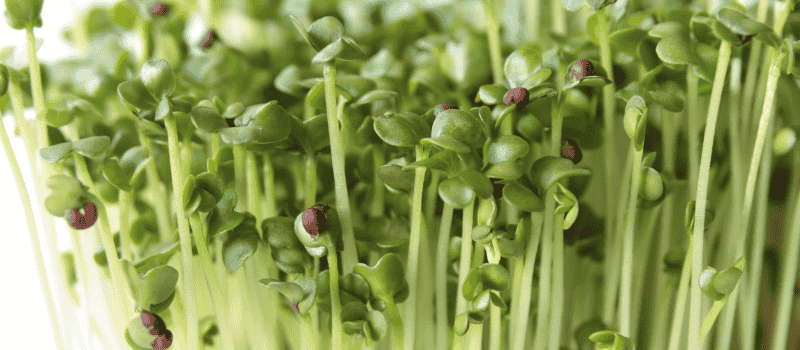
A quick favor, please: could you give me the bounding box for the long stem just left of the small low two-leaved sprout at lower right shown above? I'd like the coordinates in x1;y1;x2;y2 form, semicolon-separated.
689;41;731;350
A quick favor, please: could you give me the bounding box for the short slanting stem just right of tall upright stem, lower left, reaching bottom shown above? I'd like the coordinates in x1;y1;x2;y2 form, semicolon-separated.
189;213;234;349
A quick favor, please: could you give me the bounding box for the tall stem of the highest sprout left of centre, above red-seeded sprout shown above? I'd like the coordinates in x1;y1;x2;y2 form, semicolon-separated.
323;63;358;274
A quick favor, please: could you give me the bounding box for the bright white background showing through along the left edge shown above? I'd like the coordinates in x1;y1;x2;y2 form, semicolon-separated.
0;0;114;350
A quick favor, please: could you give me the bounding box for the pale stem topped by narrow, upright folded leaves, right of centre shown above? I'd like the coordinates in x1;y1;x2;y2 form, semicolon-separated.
619;144;643;338
